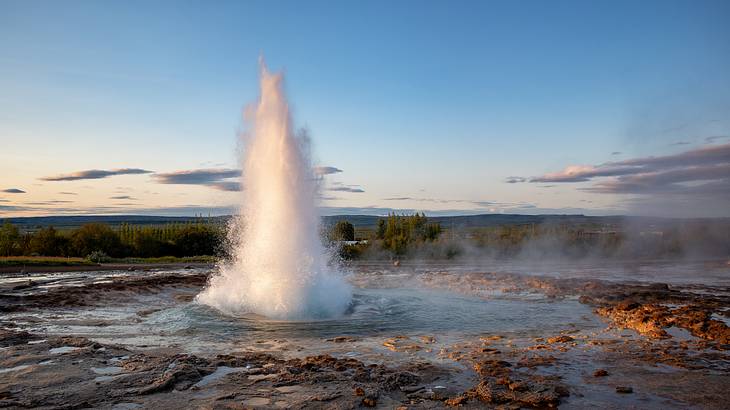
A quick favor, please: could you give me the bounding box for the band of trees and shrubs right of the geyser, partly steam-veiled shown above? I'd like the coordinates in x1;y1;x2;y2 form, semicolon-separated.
332;214;730;260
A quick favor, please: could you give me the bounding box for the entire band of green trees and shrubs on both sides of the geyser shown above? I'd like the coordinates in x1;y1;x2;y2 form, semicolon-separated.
0;213;730;265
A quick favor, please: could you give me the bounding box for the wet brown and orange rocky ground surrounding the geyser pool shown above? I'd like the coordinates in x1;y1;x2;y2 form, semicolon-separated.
0;268;730;409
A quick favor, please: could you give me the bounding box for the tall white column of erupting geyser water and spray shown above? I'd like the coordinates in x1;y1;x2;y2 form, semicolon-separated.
197;63;351;319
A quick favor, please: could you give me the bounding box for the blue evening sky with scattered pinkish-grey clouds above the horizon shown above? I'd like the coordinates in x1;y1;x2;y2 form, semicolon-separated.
0;0;730;217
